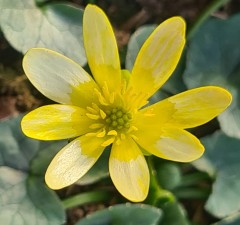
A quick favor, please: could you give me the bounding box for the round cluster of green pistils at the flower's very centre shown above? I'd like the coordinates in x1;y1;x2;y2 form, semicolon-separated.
105;108;132;130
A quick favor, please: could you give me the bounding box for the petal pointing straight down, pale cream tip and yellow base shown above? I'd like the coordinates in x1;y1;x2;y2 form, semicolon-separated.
109;137;149;202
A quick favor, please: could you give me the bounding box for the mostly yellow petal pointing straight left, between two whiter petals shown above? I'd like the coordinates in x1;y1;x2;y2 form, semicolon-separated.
21;105;92;140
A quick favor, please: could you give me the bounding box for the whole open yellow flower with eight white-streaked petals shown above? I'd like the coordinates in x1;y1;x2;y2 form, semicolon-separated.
21;5;231;202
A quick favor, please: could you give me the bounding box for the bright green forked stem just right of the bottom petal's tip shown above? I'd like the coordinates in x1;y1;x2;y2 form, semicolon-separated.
146;156;175;207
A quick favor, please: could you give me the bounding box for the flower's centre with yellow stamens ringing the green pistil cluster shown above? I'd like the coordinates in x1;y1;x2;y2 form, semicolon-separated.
86;83;137;146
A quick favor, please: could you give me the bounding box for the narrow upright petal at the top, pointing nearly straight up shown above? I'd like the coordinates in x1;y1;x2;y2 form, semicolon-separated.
83;5;121;91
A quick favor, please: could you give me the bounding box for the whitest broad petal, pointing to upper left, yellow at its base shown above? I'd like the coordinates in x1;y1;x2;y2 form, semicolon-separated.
23;48;97;107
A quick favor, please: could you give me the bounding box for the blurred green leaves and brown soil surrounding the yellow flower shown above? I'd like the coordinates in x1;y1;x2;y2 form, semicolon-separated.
0;0;240;225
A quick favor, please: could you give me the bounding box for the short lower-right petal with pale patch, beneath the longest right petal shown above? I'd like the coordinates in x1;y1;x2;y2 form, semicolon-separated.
136;127;204;162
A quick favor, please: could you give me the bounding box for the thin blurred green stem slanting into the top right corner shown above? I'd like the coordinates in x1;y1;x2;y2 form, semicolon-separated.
187;0;229;39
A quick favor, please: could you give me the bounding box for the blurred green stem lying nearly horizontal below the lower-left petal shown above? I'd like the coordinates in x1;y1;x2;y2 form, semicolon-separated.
62;191;110;209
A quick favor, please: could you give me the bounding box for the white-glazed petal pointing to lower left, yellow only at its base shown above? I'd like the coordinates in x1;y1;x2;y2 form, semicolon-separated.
45;136;104;189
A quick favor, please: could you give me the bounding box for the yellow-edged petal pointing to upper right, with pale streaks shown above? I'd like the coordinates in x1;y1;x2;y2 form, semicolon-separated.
129;17;185;101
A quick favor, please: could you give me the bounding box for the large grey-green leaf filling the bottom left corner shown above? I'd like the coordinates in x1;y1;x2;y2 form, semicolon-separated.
0;167;65;225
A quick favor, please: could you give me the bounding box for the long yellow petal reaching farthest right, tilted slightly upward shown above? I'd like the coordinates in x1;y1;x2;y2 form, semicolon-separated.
136;86;232;129
